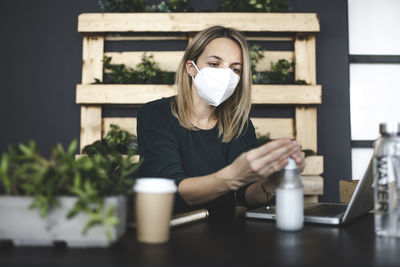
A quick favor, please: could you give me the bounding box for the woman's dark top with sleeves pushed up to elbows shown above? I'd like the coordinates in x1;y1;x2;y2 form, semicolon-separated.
137;97;257;219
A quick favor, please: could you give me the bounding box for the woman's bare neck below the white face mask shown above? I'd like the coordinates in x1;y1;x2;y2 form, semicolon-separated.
190;84;217;130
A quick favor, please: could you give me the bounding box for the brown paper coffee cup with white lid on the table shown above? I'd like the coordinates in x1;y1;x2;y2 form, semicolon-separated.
133;178;177;244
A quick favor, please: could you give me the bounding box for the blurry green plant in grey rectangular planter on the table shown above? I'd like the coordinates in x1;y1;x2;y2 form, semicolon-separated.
0;126;140;247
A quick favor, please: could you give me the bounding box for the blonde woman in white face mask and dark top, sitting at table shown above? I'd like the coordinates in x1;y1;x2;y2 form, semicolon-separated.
137;26;304;219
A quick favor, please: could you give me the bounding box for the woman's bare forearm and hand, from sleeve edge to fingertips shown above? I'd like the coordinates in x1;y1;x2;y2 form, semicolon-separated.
178;139;298;205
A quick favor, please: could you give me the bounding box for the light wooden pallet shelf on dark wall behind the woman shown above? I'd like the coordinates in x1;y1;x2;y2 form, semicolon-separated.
76;13;324;202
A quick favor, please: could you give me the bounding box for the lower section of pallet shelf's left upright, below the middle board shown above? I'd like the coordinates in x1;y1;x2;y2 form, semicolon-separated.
80;106;101;153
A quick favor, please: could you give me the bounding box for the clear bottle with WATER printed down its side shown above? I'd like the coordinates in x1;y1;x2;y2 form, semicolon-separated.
374;123;400;237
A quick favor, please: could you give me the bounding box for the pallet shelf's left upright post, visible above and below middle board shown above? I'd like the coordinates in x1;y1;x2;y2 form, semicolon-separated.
79;36;104;151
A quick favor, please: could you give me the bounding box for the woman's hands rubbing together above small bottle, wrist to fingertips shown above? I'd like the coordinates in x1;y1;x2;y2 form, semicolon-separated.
222;139;304;190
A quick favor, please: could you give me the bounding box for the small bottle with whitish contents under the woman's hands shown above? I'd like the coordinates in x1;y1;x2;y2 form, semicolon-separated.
276;158;304;231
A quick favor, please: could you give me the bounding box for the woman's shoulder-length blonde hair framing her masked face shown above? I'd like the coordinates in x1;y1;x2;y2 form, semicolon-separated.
171;26;252;143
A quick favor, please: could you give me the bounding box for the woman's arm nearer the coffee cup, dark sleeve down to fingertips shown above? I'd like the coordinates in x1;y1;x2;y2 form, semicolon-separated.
137;103;306;209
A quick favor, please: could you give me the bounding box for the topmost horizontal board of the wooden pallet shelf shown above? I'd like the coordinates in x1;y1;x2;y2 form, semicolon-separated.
78;12;320;33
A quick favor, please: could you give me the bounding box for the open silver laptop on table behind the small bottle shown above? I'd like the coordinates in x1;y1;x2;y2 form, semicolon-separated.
246;159;374;225
